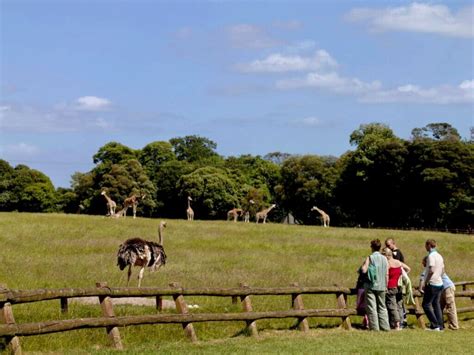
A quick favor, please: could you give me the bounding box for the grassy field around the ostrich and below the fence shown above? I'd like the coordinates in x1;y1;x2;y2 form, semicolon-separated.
0;213;474;354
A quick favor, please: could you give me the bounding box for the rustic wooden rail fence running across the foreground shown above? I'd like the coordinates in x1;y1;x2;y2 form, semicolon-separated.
0;281;474;354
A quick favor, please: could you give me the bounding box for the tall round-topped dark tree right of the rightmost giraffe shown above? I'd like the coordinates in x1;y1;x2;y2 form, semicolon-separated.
335;123;407;227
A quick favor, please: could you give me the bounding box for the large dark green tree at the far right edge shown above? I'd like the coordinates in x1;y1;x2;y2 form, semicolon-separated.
404;139;474;228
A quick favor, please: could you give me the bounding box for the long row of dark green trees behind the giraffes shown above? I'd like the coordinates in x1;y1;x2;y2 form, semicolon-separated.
0;123;474;230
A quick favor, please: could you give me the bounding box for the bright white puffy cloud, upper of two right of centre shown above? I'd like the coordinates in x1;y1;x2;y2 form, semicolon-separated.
237;50;337;73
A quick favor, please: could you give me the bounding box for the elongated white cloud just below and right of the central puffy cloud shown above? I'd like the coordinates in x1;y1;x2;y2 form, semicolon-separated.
276;72;381;94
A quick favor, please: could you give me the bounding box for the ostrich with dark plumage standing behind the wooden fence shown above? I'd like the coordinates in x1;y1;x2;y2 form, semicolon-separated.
117;221;166;287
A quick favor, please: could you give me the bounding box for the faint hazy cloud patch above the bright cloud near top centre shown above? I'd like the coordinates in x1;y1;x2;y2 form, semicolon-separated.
226;24;281;49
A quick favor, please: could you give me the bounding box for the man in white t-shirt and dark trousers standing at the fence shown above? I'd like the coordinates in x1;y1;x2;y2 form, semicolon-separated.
420;239;444;331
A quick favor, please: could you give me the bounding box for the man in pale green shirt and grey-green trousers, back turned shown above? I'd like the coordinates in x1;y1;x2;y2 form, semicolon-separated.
361;239;390;330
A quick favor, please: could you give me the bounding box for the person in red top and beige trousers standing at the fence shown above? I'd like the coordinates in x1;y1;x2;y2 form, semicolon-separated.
382;248;410;330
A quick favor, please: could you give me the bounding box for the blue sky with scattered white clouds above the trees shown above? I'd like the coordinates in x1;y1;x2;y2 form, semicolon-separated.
0;0;474;187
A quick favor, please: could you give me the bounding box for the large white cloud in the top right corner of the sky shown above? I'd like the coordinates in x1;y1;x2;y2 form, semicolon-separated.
346;2;474;38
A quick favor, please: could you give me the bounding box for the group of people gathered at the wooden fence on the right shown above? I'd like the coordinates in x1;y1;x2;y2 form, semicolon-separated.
356;238;459;331
